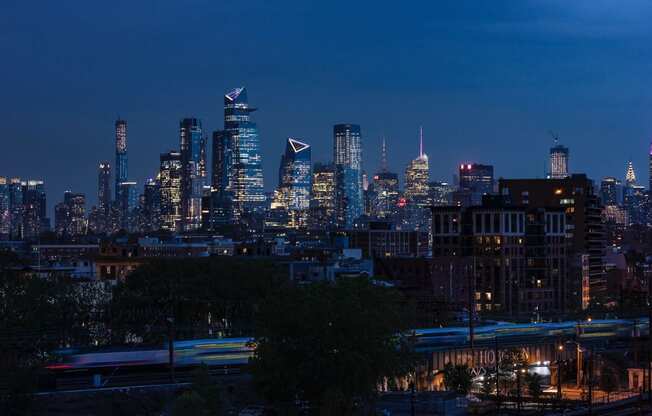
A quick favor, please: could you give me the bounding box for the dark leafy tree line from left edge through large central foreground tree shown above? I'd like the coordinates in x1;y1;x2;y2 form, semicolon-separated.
0;257;415;415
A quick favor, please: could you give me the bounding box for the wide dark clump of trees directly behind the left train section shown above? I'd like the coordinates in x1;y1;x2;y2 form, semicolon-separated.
111;256;287;344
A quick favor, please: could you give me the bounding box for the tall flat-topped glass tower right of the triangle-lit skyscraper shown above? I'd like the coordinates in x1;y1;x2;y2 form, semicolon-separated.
333;124;364;228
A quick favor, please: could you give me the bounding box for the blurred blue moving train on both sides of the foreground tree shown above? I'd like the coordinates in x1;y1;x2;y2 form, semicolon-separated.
47;318;648;372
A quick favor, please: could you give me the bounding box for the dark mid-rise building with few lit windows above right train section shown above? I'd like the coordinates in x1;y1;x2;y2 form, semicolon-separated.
432;197;568;320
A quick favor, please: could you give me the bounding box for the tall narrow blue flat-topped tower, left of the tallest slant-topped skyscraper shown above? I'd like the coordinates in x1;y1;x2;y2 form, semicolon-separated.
179;118;206;231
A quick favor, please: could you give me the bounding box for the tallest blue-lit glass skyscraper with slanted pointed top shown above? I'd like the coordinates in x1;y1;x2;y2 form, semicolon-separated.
213;87;265;220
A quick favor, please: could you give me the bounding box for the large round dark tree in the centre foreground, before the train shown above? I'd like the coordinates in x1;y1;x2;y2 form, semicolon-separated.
251;278;414;415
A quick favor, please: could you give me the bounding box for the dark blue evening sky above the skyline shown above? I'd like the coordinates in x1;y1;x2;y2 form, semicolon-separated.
0;0;652;206
